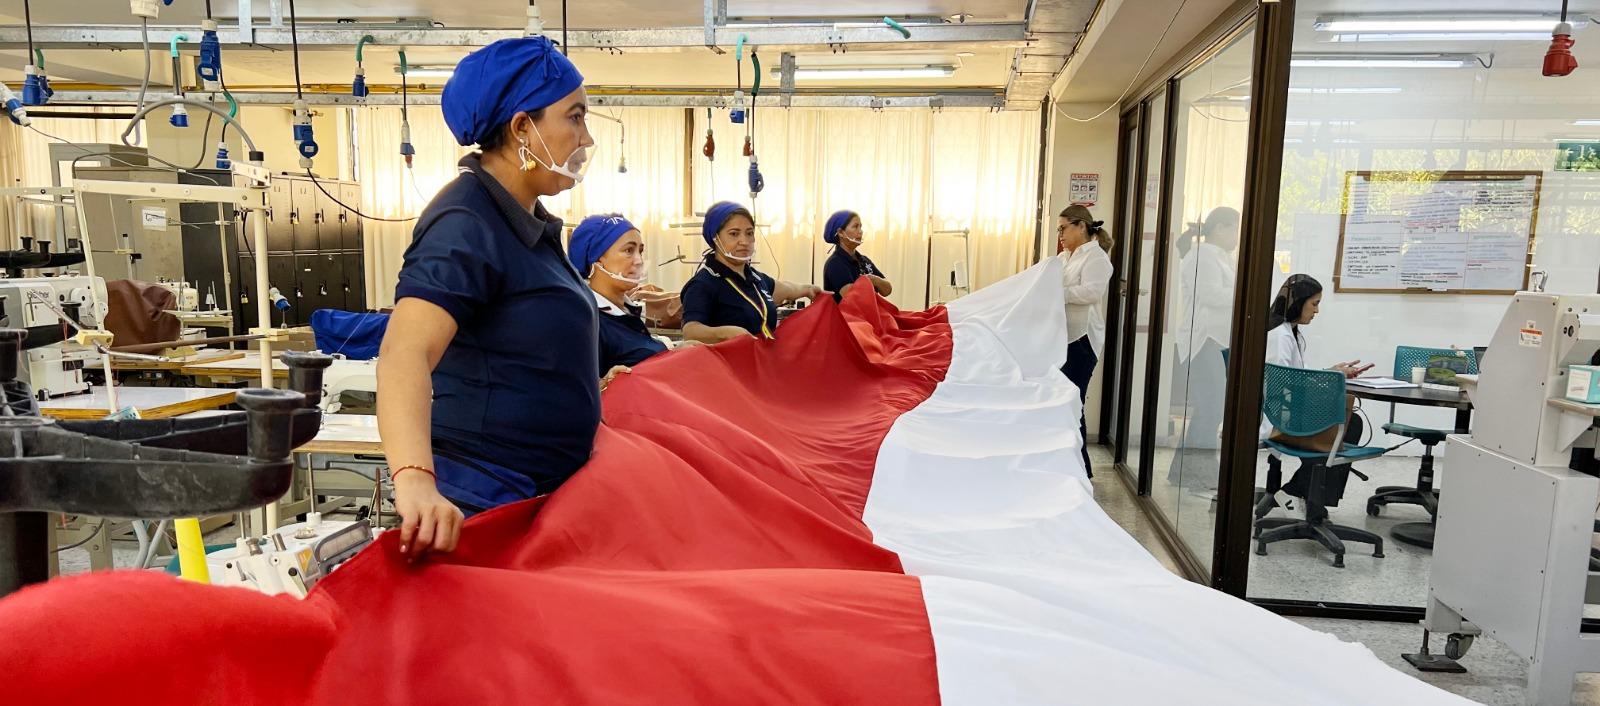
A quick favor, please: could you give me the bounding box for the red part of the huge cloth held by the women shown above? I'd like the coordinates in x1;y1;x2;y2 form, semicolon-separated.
0;280;950;706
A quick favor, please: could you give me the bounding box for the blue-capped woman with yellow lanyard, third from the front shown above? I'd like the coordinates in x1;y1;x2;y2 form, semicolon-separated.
680;202;822;343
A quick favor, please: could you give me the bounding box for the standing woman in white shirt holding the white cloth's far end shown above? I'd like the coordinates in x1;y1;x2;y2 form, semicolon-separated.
1056;205;1112;477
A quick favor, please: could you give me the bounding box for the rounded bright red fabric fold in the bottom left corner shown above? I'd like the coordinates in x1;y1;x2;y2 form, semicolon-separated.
0;570;338;706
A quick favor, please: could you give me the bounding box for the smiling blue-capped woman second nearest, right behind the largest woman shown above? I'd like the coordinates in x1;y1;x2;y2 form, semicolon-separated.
566;215;691;374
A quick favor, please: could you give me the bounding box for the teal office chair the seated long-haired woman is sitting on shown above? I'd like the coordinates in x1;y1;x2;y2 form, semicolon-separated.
1254;363;1384;568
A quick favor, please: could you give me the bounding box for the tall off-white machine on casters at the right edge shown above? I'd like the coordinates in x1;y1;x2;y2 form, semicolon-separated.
1405;291;1600;706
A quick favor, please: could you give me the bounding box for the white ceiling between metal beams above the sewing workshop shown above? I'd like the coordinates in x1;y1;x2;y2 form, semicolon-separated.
0;0;1029;90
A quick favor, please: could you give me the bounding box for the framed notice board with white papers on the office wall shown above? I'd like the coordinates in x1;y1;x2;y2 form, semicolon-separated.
1333;171;1542;295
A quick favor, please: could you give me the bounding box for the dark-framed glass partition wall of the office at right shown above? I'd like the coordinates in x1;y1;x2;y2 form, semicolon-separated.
1115;0;1600;620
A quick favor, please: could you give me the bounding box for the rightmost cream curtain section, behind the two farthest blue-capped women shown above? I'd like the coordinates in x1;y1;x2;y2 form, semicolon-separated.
685;109;1040;309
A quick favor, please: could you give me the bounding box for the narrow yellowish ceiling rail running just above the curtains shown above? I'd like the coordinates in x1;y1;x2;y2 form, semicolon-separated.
50;90;998;109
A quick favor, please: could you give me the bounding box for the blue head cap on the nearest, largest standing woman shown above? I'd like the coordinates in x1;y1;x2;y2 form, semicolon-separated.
438;37;584;146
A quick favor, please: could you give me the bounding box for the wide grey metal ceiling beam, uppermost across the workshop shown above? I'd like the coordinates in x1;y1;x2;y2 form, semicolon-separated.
0;22;1029;51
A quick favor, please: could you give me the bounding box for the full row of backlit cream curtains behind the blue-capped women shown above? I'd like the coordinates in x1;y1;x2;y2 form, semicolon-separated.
355;106;1040;309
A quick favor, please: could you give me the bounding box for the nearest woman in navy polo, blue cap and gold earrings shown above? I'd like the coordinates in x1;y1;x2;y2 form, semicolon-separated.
378;37;600;559
